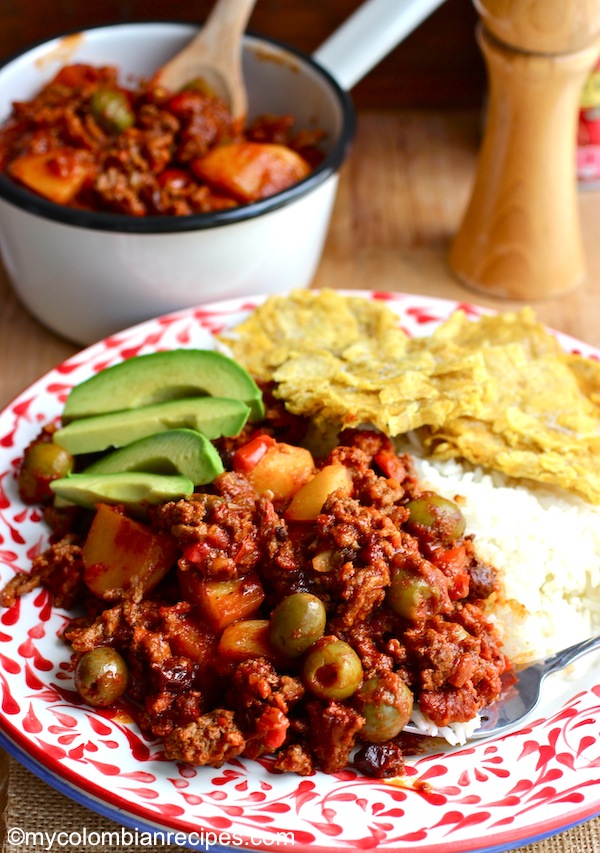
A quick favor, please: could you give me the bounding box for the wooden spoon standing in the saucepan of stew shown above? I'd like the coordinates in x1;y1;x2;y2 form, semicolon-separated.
153;0;256;123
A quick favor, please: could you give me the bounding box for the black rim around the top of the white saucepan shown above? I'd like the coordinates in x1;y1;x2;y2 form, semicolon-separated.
0;21;356;234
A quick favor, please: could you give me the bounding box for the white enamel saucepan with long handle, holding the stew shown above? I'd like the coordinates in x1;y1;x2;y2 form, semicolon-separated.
0;0;442;344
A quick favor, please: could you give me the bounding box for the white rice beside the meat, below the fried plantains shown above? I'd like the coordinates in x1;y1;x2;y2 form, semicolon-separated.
413;453;600;665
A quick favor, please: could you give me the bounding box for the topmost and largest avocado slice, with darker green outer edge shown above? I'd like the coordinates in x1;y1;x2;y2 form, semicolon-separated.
62;349;265;424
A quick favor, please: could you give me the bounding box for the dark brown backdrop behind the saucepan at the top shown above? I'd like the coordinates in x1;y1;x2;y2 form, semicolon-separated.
0;0;485;109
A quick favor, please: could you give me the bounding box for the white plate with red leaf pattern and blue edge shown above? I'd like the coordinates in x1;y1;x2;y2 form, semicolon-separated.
0;292;600;853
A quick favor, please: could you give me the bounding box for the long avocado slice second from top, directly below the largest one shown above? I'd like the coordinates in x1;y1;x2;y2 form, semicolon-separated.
53;397;250;456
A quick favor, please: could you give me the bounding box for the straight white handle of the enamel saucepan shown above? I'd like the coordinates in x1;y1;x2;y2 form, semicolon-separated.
313;0;443;89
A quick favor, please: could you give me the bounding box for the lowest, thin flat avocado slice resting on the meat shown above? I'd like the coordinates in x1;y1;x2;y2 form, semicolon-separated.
50;471;194;509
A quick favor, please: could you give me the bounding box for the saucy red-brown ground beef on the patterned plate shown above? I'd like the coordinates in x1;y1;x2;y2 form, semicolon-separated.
2;412;509;777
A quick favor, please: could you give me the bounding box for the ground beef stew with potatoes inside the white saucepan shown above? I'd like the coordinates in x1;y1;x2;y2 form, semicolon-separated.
0;64;324;217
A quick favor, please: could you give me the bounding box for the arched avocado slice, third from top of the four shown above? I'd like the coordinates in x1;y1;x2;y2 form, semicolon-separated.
83;429;224;486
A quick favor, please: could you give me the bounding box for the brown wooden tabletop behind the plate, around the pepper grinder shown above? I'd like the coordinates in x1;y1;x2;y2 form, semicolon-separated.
0;111;600;853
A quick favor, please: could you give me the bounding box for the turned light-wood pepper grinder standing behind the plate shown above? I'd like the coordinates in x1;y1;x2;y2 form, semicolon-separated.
450;0;600;300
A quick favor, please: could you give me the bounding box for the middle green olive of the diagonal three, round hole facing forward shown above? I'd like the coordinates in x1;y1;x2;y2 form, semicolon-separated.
302;637;363;699
